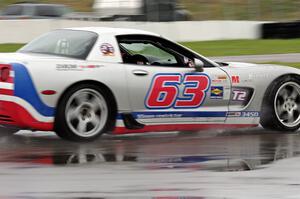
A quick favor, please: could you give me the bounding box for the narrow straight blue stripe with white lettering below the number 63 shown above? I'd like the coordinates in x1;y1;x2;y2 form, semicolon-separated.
117;111;227;119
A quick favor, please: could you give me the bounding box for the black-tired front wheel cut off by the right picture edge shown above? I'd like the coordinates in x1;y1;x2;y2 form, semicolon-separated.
260;76;300;131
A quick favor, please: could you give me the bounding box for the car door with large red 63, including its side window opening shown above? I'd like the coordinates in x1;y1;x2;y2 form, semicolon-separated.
119;34;231;124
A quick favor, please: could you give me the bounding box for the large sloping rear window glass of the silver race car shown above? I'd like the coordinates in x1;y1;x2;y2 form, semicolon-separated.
18;30;98;59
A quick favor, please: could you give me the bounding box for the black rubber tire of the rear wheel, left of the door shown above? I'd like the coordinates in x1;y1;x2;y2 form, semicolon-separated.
54;83;116;142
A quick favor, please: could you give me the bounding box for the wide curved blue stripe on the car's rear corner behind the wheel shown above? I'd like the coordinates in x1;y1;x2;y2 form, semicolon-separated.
12;63;55;117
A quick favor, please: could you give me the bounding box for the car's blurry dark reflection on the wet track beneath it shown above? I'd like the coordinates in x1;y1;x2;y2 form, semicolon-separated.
0;129;300;171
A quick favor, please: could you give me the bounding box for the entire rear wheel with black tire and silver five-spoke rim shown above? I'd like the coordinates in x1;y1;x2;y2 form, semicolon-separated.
55;84;113;141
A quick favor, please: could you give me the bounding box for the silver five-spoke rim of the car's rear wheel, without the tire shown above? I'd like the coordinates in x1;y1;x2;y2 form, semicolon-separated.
65;89;108;138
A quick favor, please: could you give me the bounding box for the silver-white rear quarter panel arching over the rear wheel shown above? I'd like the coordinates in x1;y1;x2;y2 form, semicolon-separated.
19;59;129;110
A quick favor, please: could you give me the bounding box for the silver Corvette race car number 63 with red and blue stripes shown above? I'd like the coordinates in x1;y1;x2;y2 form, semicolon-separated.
0;28;300;141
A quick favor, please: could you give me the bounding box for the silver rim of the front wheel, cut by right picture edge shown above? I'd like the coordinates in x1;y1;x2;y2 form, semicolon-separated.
274;82;300;127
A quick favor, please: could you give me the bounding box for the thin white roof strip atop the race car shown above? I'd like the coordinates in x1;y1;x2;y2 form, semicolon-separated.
66;27;159;36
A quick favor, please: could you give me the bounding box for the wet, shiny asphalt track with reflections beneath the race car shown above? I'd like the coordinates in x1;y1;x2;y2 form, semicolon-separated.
0;128;300;199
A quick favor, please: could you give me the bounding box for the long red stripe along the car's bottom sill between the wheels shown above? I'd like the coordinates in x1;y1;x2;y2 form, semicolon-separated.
113;124;258;135
